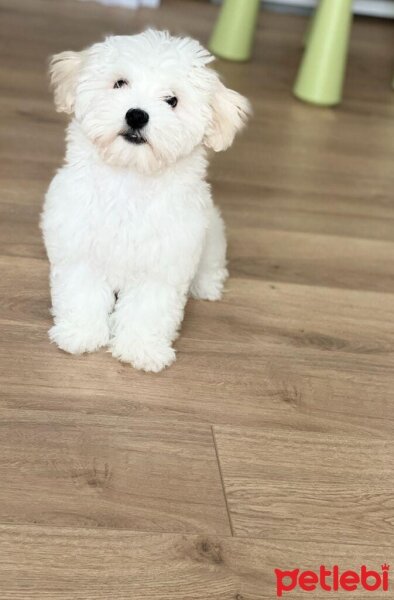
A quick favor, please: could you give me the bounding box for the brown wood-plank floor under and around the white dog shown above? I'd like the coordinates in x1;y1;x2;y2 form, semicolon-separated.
0;0;394;600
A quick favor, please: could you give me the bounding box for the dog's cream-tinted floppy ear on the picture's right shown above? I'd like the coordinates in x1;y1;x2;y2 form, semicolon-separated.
204;78;251;152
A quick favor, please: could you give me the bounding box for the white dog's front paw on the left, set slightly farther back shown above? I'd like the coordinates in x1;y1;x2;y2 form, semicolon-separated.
49;320;109;354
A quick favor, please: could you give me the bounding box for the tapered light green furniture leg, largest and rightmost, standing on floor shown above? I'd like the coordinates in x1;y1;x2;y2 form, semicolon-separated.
294;0;352;106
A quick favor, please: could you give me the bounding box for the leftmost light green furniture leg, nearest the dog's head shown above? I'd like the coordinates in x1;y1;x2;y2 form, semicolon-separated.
209;0;260;60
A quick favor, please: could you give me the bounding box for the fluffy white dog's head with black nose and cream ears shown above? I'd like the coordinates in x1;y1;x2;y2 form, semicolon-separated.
50;30;250;173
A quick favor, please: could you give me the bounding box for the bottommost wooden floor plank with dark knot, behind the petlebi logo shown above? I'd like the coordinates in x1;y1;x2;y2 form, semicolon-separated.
0;525;393;600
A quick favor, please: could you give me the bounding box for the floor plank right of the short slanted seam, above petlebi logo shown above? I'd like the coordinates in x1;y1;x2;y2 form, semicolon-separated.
215;427;394;547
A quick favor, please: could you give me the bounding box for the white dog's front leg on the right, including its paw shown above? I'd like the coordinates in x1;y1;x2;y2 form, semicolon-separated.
107;279;188;372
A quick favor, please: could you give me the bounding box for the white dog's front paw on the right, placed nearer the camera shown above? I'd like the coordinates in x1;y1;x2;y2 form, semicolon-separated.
111;338;175;373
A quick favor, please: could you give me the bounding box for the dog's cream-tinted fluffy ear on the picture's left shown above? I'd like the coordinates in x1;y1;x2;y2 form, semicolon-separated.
49;51;82;114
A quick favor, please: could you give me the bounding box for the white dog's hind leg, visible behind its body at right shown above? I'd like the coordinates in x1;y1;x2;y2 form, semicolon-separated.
190;206;228;300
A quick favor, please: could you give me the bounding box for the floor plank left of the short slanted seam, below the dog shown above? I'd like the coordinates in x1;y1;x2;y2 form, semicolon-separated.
0;411;230;534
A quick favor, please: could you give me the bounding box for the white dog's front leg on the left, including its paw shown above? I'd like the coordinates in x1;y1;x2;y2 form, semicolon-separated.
49;263;115;354
